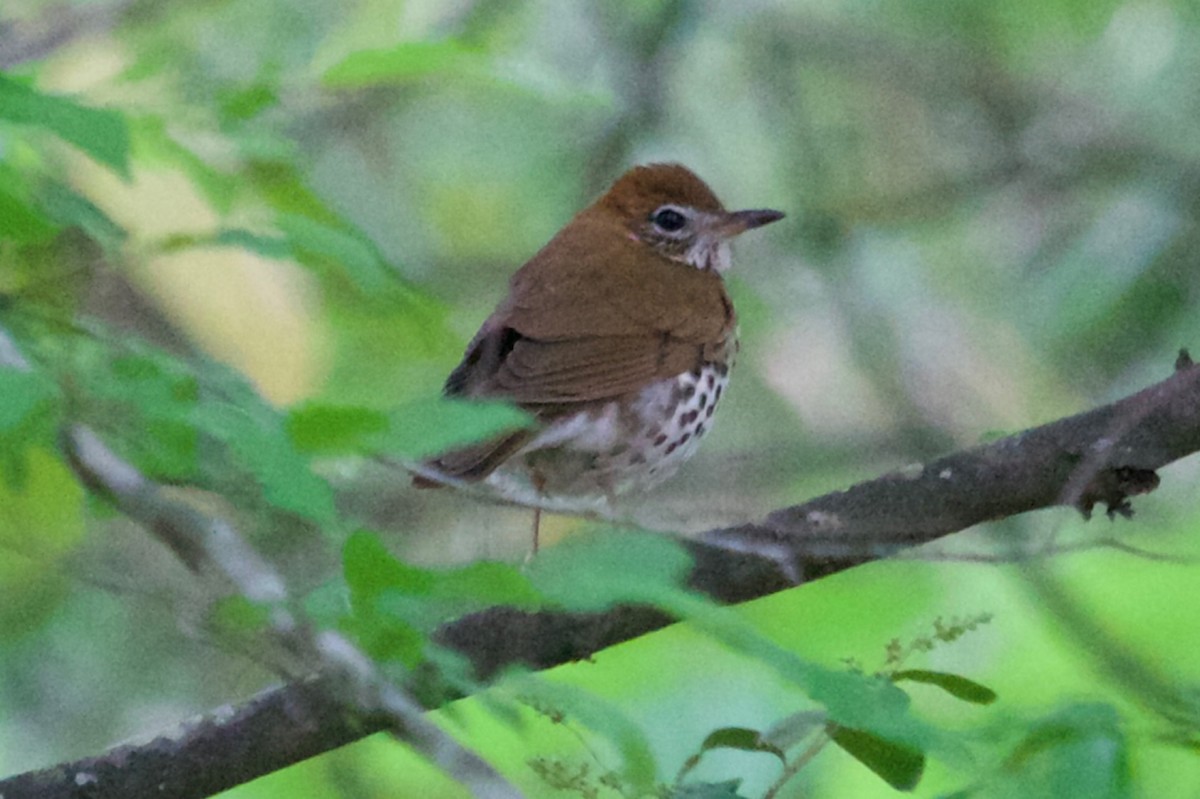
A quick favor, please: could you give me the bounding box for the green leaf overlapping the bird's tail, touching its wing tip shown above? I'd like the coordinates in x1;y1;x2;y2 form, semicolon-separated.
380;397;530;458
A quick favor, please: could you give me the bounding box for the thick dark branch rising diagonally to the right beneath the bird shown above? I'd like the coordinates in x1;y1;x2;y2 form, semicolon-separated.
0;354;1200;797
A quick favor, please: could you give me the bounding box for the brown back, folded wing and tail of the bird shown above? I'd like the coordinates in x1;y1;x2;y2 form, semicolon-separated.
433;209;733;479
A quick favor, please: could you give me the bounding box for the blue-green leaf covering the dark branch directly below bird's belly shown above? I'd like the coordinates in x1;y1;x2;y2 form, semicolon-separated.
527;528;692;611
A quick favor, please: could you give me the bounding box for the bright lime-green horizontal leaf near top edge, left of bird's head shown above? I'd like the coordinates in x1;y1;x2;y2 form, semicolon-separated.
322;40;486;89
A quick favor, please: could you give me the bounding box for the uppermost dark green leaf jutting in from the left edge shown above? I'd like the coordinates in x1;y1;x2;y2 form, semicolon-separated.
0;74;130;178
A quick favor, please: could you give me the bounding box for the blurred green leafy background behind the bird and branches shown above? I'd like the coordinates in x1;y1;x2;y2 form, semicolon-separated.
0;0;1200;797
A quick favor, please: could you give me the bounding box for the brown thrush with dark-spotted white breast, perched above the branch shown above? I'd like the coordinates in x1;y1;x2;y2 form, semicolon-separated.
418;164;784;523
